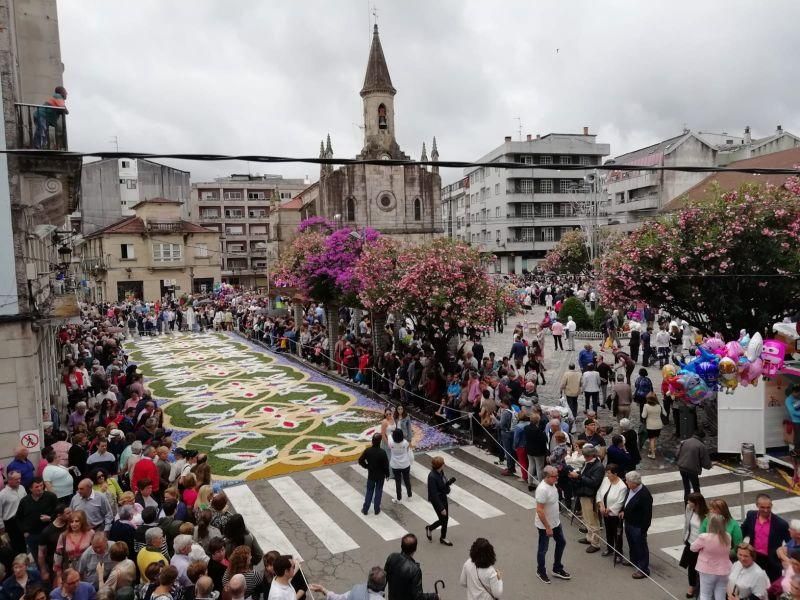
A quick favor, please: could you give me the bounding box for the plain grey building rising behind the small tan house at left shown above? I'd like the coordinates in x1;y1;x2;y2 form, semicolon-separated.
78;158;192;235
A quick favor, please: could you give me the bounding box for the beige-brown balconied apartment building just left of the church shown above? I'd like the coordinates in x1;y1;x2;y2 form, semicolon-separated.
189;174;308;288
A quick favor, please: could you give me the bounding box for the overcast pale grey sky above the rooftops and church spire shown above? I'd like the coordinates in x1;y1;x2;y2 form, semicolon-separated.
58;0;800;183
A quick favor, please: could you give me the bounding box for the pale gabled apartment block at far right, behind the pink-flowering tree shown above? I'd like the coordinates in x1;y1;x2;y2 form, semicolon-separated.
603;125;800;232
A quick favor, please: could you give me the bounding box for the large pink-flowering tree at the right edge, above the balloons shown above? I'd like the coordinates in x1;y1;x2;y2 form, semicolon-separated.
598;177;800;339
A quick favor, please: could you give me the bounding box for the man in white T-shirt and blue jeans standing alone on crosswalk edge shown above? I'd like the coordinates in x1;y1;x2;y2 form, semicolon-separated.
534;466;572;583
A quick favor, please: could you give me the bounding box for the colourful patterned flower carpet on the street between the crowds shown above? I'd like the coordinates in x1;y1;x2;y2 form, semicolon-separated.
126;333;454;480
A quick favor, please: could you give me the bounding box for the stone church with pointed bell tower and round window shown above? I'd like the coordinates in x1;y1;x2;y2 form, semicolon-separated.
317;24;443;244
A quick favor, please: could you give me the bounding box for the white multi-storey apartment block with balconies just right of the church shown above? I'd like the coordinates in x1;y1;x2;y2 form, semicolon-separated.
442;127;610;273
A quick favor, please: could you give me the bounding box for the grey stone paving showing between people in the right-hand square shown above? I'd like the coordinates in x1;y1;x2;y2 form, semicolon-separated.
483;306;717;462
